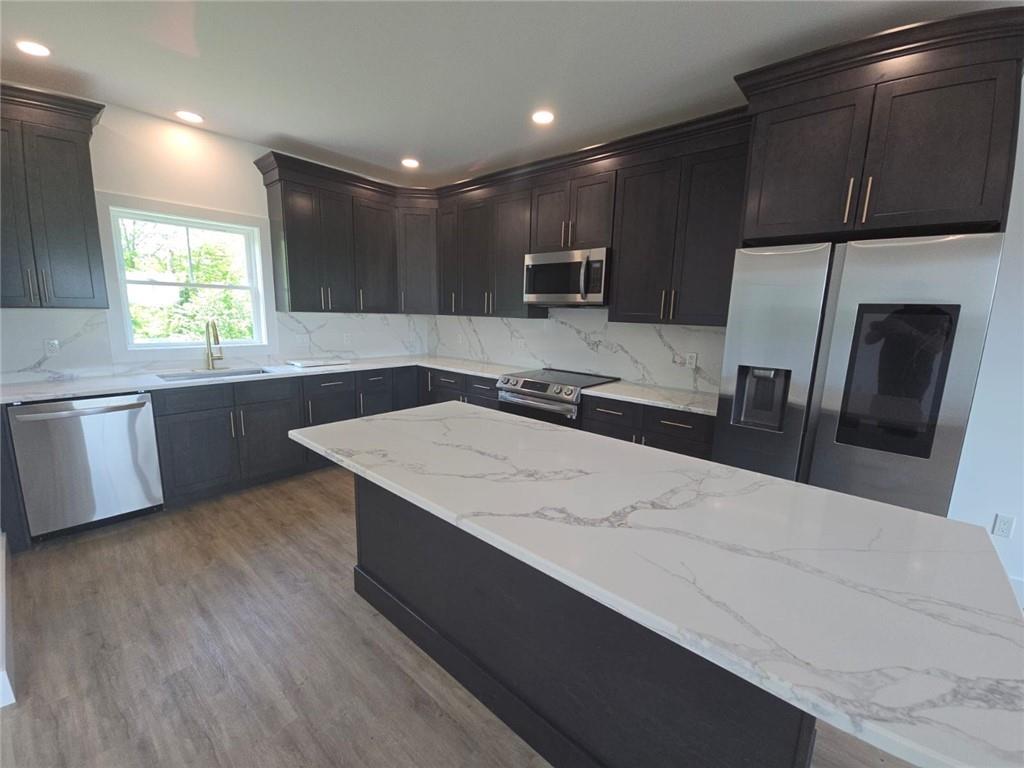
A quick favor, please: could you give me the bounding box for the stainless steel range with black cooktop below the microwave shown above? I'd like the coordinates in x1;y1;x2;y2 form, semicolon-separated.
498;368;618;426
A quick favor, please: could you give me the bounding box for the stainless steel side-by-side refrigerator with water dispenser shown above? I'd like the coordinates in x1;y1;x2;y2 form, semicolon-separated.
713;233;1004;515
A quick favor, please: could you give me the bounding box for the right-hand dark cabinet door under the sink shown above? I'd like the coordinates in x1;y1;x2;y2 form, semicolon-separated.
238;397;306;480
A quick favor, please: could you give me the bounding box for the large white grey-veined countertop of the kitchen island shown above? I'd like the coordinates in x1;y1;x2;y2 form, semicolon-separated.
291;402;1024;768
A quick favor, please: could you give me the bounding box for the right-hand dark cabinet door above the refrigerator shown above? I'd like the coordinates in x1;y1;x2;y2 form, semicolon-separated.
856;61;1020;229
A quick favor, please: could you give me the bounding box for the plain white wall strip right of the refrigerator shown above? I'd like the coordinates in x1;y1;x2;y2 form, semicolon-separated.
949;93;1024;605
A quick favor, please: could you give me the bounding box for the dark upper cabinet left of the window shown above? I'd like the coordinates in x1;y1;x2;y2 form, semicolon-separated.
0;86;108;308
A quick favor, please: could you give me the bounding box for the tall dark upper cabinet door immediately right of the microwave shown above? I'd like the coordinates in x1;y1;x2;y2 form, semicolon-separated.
609;159;680;323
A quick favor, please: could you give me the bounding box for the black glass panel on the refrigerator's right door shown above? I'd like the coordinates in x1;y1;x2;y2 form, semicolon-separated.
836;304;959;459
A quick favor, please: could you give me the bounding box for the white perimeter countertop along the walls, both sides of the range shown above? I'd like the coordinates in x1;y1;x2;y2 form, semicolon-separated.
0;355;718;416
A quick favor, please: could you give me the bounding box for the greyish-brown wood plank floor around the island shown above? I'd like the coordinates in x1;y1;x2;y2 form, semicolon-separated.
0;469;906;768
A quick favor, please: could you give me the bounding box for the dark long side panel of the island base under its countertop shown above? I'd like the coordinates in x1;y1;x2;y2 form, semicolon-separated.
355;477;815;768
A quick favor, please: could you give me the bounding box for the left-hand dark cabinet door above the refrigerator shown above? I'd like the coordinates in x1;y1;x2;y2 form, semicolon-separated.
743;86;874;241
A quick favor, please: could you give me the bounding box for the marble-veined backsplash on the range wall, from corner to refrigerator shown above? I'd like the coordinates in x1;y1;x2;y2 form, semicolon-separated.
431;308;725;392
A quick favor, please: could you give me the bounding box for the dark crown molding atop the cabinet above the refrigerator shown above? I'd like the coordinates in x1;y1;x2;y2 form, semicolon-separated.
734;7;1024;104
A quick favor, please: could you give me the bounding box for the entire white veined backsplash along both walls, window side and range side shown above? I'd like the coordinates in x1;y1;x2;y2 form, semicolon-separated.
0;309;725;392
